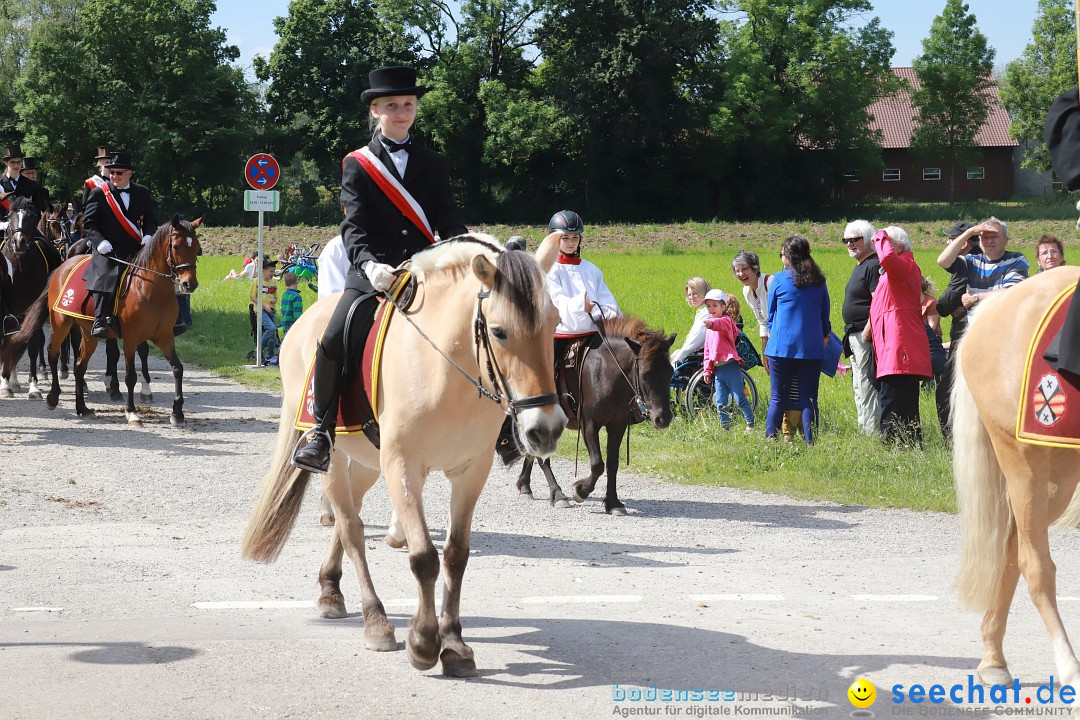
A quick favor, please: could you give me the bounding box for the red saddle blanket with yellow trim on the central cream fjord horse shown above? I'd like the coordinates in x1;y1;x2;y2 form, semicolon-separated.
293;300;393;435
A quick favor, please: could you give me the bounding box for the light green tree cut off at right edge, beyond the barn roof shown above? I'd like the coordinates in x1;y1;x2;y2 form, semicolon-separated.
1001;0;1077;172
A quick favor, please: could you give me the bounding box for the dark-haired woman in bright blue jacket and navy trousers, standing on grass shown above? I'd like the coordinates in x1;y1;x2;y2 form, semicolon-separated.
765;235;833;445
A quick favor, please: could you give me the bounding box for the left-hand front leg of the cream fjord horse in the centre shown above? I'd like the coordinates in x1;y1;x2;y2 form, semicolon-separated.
384;453;438;670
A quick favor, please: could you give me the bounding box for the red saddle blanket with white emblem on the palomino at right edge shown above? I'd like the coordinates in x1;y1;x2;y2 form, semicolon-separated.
1016;285;1080;448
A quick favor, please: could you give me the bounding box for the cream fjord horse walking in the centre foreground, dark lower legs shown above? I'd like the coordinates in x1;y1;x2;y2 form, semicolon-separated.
243;235;566;677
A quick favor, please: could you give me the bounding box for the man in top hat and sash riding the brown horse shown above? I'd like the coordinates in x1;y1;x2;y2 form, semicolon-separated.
82;152;158;338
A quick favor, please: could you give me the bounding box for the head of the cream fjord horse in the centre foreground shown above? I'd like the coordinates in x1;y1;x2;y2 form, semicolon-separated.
472;239;566;458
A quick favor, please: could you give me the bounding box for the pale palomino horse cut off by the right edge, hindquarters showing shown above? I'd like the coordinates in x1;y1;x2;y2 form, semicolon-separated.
953;267;1080;688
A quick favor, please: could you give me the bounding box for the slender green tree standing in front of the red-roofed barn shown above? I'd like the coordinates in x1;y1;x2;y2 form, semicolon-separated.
912;0;994;200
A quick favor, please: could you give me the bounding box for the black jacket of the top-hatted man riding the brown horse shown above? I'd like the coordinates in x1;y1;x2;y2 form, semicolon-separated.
82;182;158;293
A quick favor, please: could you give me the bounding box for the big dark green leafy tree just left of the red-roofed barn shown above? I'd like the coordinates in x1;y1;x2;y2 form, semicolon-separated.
711;0;896;215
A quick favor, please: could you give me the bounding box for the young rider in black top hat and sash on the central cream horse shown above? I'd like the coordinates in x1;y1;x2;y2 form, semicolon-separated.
293;67;468;473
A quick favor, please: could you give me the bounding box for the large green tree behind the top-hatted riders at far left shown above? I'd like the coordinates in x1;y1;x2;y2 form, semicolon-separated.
16;0;257;212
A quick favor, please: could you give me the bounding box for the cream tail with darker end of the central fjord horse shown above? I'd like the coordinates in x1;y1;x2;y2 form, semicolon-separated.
241;411;311;562
